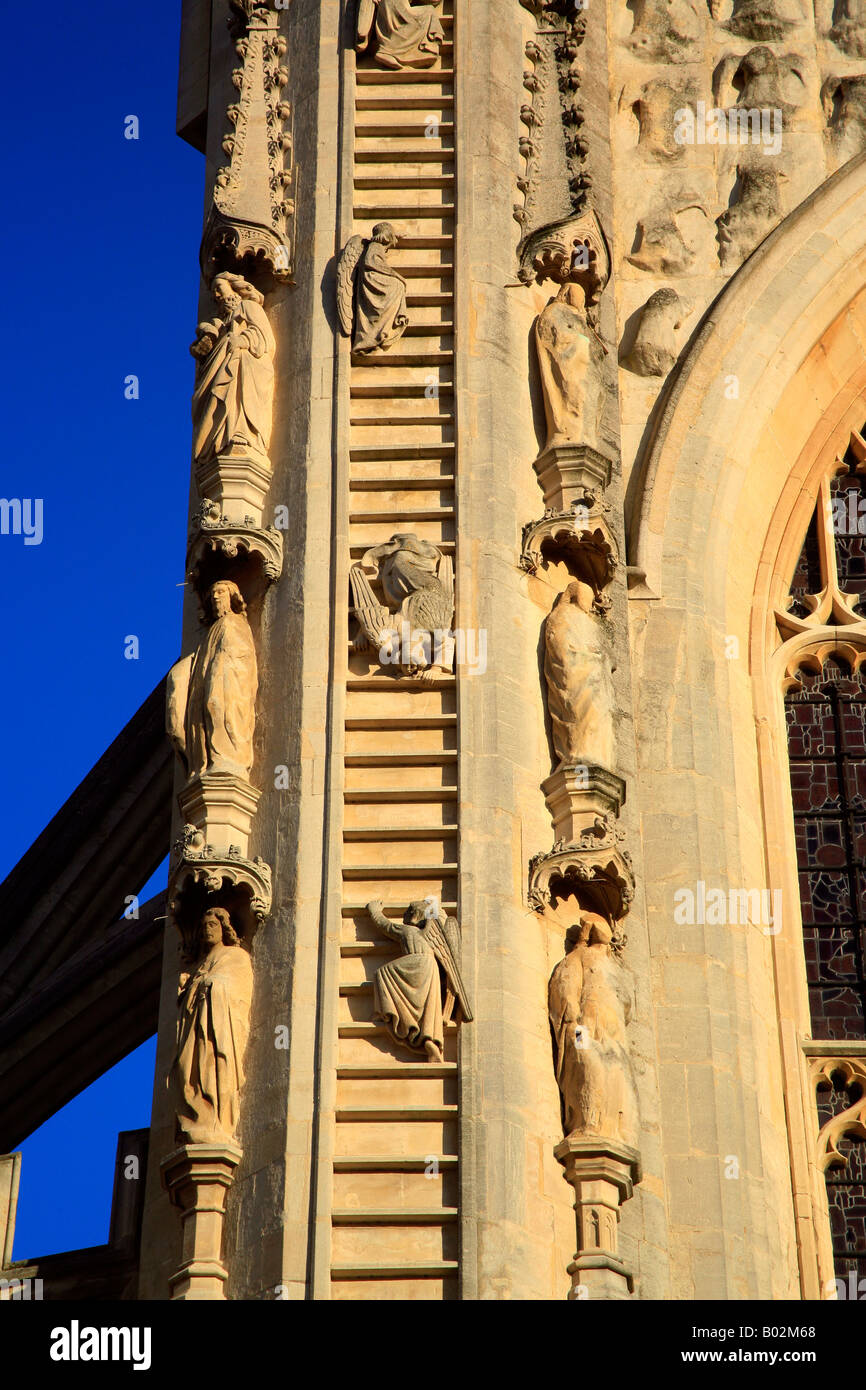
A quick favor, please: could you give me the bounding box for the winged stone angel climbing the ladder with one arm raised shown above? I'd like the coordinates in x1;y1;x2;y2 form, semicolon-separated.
367;898;473;1062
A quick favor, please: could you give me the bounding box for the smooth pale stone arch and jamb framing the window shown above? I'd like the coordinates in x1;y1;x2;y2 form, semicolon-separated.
630;160;865;1298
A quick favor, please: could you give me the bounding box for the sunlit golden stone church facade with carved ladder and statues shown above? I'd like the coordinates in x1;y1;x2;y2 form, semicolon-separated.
4;0;866;1301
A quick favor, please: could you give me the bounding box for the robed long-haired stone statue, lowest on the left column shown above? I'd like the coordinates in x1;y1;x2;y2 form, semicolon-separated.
171;908;253;1144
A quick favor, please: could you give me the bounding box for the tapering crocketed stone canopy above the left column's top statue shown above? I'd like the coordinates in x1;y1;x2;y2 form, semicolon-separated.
200;0;296;292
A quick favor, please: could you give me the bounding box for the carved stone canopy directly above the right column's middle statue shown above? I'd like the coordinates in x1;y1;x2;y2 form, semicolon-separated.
520;495;619;613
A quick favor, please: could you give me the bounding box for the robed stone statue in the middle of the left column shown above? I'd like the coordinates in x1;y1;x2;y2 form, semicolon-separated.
165;580;259;780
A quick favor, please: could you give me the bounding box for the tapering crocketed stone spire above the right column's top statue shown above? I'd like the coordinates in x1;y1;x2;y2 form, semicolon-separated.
514;0;589;264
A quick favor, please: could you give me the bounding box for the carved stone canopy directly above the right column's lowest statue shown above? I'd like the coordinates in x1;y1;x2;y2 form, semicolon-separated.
528;816;634;922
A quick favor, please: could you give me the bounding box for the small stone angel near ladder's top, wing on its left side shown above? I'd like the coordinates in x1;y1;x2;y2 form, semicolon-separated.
336;222;409;353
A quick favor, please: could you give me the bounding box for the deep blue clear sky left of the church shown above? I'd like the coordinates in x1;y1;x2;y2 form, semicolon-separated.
0;0;204;1258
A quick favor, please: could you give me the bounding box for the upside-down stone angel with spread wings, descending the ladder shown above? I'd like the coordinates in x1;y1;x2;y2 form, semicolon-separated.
349;532;455;681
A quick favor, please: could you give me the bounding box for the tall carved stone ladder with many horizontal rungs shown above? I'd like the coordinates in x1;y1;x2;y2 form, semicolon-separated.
331;0;457;1300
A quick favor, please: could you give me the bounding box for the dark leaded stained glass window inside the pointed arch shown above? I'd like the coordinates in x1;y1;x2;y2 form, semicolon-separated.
777;431;866;1280
